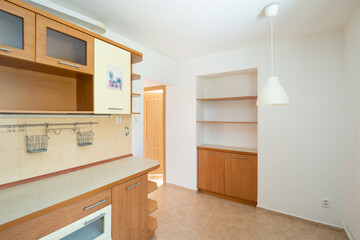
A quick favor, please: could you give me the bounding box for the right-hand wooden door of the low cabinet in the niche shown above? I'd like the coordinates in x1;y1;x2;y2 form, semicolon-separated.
225;153;257;202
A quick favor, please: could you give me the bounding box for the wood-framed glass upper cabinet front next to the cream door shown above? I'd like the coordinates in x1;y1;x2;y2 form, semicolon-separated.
36;15;94;74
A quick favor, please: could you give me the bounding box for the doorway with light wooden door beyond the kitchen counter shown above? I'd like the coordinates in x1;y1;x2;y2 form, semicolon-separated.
144;86;166;186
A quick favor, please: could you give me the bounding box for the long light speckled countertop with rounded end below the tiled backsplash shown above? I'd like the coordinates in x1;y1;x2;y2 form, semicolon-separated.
0;157;159;225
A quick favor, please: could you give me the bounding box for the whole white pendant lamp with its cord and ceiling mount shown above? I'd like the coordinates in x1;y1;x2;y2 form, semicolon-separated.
256;4;289;106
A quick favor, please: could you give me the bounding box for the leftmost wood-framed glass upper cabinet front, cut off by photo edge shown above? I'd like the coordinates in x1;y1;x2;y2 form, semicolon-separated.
0;1;35;61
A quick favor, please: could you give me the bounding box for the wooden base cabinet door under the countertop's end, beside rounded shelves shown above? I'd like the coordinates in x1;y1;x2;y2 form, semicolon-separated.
111;174;148;240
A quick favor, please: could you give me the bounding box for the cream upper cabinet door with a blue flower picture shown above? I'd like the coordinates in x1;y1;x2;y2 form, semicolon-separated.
94;39;131;114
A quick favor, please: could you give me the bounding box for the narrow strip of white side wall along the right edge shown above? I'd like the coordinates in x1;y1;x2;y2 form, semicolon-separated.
344;4;360;239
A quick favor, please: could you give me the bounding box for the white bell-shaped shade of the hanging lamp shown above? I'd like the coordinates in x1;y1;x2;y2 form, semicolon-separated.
256;76;289;106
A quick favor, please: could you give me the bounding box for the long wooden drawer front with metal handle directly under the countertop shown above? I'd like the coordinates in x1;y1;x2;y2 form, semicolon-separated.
0;189;111;240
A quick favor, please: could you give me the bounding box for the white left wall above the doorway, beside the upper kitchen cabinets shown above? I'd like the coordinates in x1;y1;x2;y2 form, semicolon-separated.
104;30;178;156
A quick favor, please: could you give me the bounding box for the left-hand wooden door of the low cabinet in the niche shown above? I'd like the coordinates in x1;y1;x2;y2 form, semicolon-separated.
198;150;225;194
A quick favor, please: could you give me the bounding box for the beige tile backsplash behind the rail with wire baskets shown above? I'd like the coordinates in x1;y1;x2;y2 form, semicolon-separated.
0;115;132;185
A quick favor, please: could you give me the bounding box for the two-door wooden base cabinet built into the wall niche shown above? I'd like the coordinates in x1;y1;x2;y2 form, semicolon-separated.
198;146;257;206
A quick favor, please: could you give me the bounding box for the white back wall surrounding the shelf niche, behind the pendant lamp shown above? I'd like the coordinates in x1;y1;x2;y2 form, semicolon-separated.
167;31;345;226
